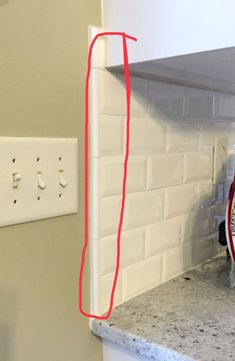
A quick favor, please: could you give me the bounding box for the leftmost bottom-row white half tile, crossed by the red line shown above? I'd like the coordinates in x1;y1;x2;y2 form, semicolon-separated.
99;271;123;314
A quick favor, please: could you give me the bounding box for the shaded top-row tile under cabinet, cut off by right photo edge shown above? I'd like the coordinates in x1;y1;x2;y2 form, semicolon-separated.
215;93;235;120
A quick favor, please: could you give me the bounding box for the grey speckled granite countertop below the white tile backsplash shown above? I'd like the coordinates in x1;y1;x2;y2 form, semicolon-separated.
92;256;235;361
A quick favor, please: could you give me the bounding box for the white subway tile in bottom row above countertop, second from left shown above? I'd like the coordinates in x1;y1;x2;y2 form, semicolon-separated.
122;255;162;300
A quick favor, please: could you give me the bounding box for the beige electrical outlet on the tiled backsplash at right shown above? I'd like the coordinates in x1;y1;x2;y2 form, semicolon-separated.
213;136;228;184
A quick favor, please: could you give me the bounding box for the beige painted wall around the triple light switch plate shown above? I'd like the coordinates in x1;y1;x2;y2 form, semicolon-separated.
0;0;101;361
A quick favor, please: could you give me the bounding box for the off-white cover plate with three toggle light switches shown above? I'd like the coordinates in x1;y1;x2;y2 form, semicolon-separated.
0;137;78;227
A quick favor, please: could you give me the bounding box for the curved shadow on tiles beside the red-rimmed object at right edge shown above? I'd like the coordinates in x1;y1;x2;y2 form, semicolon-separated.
182;169;226;271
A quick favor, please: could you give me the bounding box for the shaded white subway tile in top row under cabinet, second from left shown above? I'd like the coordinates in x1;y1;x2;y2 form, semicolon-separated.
148;81;185;119
